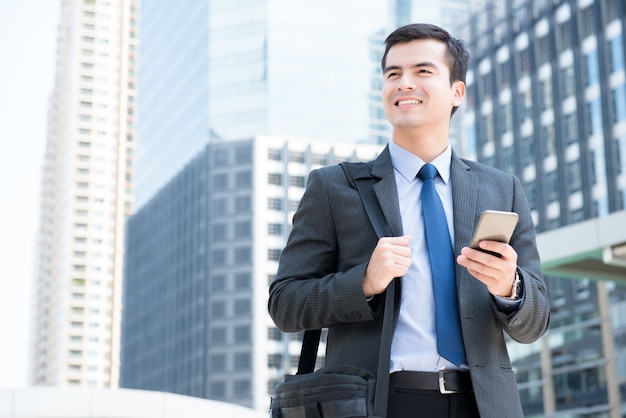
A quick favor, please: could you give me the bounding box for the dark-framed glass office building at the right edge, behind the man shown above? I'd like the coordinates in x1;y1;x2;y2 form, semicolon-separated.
461;0;626;418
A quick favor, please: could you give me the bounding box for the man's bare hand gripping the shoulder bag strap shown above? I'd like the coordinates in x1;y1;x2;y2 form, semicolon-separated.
363;235;411;297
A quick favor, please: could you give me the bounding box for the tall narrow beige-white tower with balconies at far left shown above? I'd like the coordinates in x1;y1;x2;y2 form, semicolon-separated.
30;0;138;387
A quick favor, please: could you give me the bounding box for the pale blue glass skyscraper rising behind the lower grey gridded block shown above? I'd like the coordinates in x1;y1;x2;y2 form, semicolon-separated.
135;0;394;208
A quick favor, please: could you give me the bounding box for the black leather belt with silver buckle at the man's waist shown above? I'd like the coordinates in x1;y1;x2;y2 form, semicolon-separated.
389;369;474;394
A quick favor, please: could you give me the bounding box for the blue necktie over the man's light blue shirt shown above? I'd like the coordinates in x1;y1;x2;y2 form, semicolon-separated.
417;164;465;366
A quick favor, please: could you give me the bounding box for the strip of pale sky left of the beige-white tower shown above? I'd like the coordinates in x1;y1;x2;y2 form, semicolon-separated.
0;0;61;390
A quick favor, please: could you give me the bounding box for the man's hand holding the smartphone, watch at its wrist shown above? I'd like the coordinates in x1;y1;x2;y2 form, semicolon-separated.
456;241;517;297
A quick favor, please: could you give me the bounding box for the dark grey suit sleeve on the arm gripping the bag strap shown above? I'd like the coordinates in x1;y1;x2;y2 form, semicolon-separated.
268;167;375;332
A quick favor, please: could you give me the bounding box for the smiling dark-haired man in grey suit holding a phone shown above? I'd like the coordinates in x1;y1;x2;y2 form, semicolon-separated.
269;24;550;418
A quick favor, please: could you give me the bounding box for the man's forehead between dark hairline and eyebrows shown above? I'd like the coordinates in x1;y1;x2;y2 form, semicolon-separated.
385;39;447;67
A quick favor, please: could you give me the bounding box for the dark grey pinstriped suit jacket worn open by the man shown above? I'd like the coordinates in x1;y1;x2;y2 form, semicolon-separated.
269;148;550;418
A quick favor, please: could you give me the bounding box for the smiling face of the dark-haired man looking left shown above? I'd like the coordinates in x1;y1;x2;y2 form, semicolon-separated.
382;39;465;146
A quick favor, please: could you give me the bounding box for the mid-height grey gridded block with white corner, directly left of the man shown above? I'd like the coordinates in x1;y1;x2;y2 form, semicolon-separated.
120;136;382;411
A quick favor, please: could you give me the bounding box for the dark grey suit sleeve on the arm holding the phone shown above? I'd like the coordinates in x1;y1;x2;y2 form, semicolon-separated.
494;177;550;343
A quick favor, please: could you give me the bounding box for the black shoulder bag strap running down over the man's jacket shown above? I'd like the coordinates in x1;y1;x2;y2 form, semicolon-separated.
297;162;396;417
